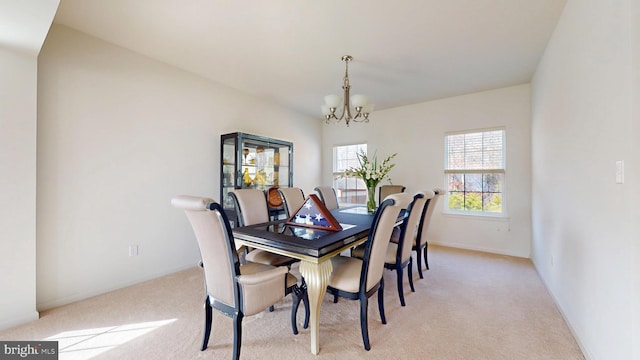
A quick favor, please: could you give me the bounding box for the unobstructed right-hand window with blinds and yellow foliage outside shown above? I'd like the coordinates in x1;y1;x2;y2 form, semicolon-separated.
444;129;505;215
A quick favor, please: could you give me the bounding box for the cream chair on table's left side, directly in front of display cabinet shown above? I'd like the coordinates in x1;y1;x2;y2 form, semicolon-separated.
229;189;299;266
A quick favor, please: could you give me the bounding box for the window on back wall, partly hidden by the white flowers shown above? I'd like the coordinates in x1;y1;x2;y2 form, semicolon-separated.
333;144;367;206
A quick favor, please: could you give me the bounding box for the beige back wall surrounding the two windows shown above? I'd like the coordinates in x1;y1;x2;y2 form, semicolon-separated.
322;84;531;257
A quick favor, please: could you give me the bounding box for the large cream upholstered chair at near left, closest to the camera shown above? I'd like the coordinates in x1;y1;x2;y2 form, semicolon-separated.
171;195;306;359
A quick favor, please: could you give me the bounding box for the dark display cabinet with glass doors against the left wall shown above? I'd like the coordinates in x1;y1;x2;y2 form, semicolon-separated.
220;132;293;225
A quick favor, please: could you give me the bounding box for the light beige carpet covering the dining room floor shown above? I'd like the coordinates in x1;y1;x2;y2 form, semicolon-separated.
0;246;584;360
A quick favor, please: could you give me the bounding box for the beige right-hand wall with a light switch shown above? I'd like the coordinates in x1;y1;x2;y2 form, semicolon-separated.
532;0;640;359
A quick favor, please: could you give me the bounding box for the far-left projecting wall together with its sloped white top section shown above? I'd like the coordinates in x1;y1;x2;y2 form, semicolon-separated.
0;0;59;330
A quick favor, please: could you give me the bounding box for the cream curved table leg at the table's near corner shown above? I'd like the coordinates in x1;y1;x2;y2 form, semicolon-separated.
300;260;333;355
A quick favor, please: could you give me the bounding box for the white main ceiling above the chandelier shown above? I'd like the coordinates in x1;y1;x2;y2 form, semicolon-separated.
55;0;566;119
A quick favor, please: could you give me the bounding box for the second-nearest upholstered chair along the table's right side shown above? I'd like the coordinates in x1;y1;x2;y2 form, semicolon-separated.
351;192;427;306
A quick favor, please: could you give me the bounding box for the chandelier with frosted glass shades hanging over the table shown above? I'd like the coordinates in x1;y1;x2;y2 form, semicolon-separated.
321;55;374;126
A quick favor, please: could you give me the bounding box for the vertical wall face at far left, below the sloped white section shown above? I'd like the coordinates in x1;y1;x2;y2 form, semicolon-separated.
0;46;38;330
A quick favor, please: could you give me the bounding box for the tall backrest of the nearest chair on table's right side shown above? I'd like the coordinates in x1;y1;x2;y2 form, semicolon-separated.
360;199;401;292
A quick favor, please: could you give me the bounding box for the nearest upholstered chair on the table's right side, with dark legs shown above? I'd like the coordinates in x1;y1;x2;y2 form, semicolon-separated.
327;199;400;350
